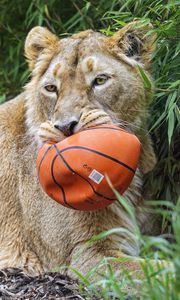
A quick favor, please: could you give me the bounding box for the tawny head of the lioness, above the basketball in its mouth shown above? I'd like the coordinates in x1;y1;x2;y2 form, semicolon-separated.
25;22;155;172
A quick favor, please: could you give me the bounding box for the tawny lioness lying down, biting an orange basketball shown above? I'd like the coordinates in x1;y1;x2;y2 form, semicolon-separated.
0;23;156;274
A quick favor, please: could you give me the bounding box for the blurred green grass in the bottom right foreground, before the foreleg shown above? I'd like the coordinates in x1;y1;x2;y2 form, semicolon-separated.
71;193;180;300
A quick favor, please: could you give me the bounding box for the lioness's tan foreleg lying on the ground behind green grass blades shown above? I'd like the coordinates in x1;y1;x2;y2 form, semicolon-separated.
70;245;172;284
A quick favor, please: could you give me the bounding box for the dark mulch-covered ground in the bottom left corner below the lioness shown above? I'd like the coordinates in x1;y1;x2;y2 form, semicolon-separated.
0;269;97;300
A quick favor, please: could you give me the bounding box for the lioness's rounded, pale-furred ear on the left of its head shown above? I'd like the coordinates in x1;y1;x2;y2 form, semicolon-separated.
25;26;59;70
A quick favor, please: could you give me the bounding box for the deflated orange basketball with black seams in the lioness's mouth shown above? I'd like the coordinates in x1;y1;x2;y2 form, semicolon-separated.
37;125;140;211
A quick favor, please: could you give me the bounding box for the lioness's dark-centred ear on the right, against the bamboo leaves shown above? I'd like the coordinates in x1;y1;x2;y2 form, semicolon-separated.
110;21;156;70
